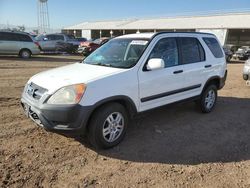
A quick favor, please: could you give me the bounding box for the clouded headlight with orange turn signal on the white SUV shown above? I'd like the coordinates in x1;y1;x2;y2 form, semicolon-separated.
47;84;86;104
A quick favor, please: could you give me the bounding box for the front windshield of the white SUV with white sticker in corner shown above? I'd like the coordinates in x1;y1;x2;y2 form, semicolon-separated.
83;38;148;68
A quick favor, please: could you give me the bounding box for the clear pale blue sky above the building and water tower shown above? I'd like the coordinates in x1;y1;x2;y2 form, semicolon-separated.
0;0;250;29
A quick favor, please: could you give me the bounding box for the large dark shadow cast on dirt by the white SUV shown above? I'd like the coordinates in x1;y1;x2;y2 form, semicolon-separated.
75;97;250;165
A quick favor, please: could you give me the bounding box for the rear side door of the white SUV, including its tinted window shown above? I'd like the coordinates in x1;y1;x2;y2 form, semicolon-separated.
177;36;210;98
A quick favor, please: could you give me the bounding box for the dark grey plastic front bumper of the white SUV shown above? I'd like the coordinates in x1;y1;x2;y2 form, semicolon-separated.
21;93;92;135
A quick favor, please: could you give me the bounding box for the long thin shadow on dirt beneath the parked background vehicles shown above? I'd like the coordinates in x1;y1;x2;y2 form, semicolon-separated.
0;54;83;63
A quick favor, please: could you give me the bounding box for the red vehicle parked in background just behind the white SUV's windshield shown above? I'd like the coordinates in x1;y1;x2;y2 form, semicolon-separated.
78;37;110;56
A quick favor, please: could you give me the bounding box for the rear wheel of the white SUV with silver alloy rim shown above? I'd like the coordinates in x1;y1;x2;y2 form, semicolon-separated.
198;85;217;113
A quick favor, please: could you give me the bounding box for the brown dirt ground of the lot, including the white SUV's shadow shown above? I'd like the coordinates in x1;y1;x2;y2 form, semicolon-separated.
0;56;250;188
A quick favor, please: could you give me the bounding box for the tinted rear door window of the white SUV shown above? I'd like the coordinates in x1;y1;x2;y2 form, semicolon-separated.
179;37;205;64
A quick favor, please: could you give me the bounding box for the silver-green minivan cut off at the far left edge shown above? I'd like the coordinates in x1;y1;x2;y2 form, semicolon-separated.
0;31;40;58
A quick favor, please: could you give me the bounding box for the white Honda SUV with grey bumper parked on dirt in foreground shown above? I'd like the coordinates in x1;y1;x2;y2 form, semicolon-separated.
21;32;227;148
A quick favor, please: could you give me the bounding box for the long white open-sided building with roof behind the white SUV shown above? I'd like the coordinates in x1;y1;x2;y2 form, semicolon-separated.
62;13;250;46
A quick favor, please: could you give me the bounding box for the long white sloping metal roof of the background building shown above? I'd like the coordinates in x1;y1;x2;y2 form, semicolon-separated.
64;13;250;30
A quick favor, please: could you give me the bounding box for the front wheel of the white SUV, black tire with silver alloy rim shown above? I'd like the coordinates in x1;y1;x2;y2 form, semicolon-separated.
88;103;129;149
